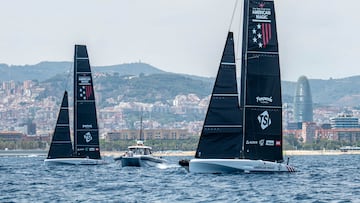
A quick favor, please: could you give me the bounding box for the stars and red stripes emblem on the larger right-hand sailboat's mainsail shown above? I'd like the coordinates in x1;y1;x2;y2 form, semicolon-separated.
251;23;271;48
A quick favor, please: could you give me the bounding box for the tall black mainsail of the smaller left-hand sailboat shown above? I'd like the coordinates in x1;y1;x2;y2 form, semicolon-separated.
74;45;101;159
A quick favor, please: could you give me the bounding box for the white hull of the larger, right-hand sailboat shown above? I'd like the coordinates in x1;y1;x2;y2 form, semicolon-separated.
189;159;295;173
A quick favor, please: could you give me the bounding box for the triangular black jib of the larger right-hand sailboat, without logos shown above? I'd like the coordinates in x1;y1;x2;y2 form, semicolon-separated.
195;32;242;159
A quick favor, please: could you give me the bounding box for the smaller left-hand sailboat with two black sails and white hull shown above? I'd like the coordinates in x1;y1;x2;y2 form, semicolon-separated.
45;45;104;165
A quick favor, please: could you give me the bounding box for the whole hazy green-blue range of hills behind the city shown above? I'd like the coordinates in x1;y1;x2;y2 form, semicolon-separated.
0;62;360;106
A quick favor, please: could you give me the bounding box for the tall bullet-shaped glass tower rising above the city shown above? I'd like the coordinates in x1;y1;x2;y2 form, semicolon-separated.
294;76;313;122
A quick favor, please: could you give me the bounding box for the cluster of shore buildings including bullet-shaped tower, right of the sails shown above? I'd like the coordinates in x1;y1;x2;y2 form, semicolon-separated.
284;76;360;143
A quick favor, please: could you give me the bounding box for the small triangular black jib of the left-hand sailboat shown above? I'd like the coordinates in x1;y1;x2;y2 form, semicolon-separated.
47;91;73;159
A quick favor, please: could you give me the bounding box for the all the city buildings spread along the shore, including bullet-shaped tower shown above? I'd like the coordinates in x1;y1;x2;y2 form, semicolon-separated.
0;76;360;146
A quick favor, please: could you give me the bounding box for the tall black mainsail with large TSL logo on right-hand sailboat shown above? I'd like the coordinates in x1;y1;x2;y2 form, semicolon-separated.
240;0;283;161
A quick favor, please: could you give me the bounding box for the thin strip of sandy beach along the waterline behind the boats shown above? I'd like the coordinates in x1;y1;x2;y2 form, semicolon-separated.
0;150;360;157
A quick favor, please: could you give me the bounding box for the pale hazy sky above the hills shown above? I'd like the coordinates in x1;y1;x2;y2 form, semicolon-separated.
0;0;360;81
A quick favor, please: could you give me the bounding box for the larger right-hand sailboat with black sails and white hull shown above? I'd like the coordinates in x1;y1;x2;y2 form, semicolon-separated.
189;0;295;173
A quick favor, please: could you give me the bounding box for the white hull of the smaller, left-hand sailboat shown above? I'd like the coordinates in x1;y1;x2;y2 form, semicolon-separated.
44;158;106;165
